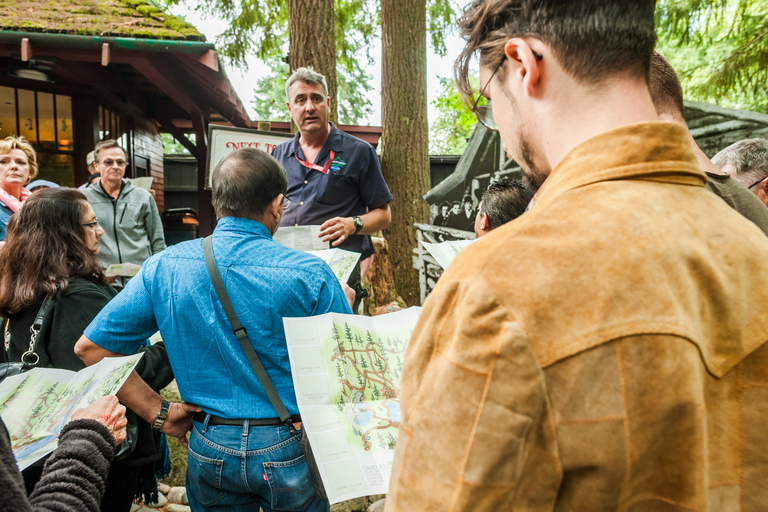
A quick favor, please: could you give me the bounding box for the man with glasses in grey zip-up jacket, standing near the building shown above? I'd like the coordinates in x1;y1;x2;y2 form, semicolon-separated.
83;139;165;288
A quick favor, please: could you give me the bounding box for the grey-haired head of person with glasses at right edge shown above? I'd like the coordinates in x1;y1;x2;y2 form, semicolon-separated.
712;139;768;206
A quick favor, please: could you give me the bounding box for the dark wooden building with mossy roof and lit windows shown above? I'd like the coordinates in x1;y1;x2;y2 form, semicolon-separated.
0;0;254;233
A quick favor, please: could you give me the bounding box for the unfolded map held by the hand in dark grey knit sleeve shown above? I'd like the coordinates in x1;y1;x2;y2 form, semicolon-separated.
0;354;143;471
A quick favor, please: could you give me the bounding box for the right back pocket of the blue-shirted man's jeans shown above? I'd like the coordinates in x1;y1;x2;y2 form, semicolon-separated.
264;455;315;510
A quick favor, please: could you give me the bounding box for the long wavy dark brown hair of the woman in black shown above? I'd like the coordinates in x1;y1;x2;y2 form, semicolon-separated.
0;188;104;317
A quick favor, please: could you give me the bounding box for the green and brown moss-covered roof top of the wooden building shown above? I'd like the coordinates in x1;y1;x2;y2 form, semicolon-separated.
0;0;205;41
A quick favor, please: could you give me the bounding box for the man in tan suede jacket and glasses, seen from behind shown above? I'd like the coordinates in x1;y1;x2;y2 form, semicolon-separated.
386;0;768;512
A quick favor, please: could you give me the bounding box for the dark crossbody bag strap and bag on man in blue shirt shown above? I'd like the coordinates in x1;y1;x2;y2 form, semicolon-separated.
203;236;328;498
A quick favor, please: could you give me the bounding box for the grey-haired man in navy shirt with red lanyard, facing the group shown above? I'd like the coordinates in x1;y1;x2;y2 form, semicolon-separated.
272;68;392;282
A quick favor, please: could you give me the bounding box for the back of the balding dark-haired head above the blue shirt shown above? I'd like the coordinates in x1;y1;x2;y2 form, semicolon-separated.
211;148;288;219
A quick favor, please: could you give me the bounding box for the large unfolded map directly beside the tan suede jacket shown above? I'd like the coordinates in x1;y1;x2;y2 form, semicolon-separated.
283;308;421;503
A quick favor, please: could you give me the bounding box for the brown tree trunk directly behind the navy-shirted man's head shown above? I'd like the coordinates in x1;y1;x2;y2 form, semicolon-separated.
288;0;338;124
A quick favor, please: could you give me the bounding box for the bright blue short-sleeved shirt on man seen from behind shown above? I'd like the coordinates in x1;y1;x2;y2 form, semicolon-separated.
85;217;351;418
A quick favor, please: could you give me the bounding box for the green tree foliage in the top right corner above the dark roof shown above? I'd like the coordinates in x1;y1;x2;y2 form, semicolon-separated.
656;0;768;113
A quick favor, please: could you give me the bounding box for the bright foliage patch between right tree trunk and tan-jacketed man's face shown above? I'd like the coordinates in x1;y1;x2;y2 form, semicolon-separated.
429;77;478;155
